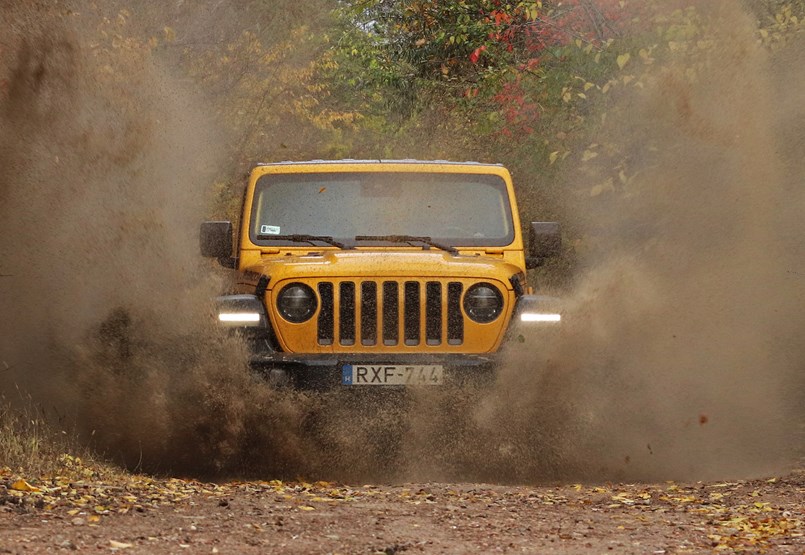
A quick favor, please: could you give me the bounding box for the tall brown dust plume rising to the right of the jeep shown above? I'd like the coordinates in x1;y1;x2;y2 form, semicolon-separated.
464;2;805;480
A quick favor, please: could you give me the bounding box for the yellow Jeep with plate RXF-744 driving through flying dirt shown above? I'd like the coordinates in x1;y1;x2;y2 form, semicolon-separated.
200;160;561;388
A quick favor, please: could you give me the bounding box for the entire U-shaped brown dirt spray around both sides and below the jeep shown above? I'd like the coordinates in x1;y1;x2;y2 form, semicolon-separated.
0;2;805;482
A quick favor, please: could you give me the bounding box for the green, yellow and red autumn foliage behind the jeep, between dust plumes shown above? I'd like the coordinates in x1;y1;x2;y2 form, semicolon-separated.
22;0;805;262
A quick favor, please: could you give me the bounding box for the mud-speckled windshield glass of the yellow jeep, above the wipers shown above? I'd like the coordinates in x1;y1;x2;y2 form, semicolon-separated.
250;172;514;247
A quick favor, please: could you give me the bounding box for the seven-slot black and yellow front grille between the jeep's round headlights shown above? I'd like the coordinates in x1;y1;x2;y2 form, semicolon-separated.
317;280;464;347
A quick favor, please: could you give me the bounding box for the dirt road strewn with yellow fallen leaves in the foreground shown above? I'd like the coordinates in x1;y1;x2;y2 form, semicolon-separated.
0;470;805;554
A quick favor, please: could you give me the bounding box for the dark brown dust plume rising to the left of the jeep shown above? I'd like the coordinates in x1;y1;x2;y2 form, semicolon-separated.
0;2;320;474
